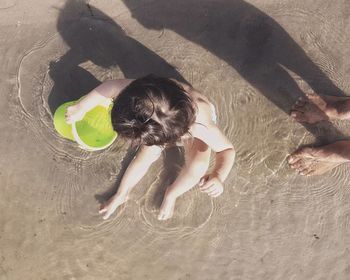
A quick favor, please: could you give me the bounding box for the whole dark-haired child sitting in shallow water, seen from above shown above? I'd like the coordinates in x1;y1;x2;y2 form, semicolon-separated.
66;75;235;220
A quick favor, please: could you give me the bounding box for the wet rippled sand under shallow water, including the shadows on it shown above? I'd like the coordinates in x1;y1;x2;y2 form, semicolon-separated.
0;0;350;280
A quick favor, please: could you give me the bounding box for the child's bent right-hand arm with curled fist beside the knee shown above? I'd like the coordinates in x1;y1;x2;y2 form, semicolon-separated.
193;124;236;196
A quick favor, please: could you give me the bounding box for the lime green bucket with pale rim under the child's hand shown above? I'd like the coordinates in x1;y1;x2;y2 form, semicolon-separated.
53;101;117;151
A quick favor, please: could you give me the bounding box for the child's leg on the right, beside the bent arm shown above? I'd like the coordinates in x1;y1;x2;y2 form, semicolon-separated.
158;139;211;220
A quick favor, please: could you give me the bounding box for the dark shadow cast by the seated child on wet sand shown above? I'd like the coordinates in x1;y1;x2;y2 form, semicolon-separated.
48;0;187;202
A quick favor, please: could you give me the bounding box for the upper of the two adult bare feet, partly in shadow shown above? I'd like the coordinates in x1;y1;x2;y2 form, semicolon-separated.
291;93;350;124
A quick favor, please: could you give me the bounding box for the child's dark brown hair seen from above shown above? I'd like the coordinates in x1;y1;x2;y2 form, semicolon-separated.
111;75;196;146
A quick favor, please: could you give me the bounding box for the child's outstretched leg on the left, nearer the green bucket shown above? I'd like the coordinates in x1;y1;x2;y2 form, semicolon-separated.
99;146;162;219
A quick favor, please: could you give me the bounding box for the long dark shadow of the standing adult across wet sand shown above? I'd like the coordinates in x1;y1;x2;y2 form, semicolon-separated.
123;0;344;140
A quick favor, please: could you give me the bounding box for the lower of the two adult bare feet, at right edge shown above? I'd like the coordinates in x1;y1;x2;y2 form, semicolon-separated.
288;141;350;176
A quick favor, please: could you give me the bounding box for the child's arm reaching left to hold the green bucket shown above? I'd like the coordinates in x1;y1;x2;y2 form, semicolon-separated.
66;79;133;123
